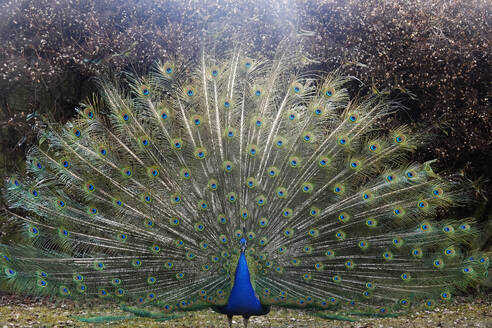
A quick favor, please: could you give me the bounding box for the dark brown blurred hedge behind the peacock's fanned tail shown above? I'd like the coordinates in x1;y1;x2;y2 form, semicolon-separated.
0;0;492;284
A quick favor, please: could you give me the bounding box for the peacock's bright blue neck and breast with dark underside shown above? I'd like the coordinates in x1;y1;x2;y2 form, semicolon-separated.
213;250;270;318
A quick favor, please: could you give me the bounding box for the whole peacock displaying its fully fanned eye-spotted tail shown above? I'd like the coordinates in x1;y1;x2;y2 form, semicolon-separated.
0;37;489;327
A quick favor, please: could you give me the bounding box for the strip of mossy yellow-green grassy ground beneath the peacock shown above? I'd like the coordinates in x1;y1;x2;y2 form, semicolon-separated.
0;296;492;328
